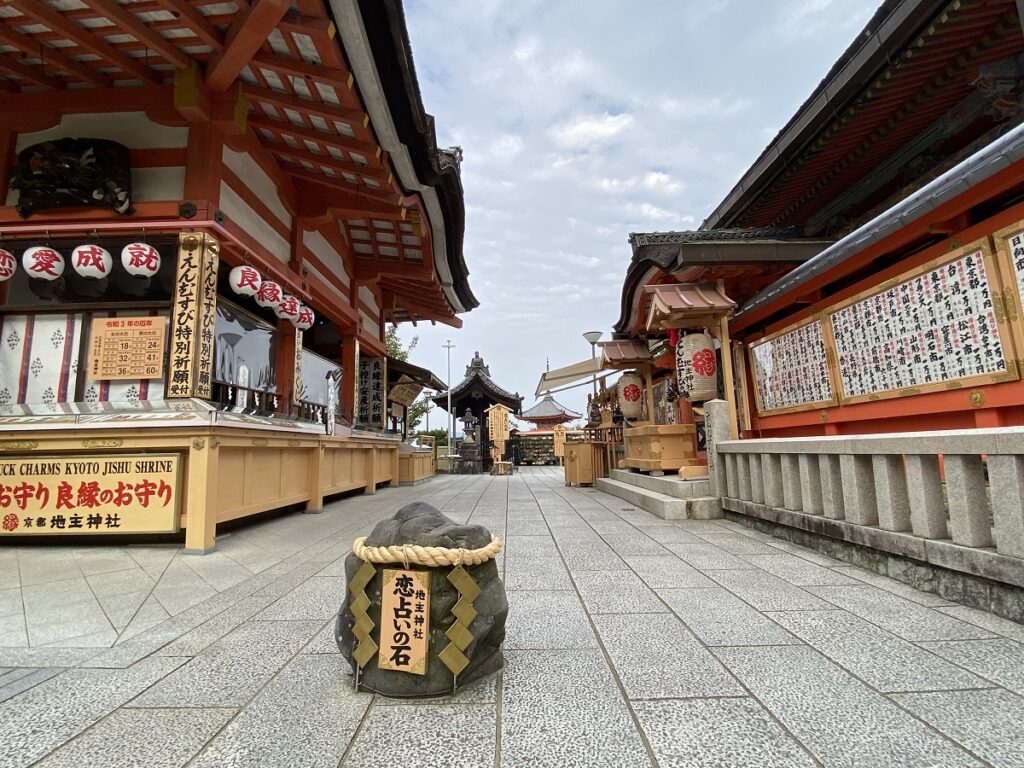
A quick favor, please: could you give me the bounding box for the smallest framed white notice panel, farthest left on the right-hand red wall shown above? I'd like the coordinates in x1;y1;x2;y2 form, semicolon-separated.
750;317;836;414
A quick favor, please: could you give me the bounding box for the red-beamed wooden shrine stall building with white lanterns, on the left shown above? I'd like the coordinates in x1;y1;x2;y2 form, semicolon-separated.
0;0;477;553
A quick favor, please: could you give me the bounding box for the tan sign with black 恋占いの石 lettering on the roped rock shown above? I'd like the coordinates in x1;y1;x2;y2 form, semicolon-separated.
377;568;430;675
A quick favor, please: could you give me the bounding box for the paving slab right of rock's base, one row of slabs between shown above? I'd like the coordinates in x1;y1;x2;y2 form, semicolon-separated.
594;613;745;698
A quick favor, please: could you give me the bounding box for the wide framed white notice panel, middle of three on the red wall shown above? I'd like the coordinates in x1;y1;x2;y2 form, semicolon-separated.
825;243;1016;402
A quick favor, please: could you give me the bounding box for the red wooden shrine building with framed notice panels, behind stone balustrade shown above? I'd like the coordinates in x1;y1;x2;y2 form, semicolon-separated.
615;0;1024;437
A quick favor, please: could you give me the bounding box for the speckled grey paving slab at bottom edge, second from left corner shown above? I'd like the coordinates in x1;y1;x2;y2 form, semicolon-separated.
36;709;234;768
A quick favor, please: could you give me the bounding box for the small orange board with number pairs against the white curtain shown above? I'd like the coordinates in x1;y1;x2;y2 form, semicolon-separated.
89;316;167;381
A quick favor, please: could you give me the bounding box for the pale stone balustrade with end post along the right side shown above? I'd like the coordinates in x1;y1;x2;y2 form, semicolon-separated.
709;402;1024;606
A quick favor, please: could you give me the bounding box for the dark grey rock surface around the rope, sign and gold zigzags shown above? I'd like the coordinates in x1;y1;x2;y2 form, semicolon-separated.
335;502;509;697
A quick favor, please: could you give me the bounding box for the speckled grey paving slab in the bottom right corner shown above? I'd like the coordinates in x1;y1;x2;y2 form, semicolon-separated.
893;689;1024;766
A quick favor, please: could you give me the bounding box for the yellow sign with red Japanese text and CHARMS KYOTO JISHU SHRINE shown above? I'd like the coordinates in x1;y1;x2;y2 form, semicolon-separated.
0;454;181;537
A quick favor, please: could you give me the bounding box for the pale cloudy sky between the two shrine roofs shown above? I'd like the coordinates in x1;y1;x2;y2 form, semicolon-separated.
401;0;878;427
